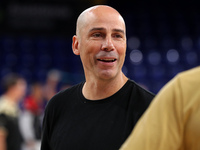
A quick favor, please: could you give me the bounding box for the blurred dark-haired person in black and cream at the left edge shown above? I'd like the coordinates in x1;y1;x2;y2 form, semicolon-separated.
0;74;27;150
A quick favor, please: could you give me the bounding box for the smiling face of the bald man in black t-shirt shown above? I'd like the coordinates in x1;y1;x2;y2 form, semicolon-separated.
73;6;126;79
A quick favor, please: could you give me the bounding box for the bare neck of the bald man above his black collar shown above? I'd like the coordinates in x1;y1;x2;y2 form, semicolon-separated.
82;73;128;100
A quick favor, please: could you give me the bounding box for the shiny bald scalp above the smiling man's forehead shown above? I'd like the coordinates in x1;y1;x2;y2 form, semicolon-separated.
76;5;125;36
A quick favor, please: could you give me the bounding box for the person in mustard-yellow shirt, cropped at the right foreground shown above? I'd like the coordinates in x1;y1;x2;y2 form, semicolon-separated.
121;67;200;150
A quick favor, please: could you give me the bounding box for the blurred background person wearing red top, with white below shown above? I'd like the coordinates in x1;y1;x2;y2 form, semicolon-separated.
20;82;45;150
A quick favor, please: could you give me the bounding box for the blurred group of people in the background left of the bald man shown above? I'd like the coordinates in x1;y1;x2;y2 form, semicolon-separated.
0;70;71;150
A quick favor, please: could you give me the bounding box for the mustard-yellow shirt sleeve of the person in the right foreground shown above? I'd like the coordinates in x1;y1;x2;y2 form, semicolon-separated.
120;78;183;150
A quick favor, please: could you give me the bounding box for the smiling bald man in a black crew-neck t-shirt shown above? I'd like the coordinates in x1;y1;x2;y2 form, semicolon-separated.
41;5;154;150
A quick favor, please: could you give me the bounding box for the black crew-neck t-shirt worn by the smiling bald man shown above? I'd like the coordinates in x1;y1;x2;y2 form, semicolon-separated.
41;80;154;150
